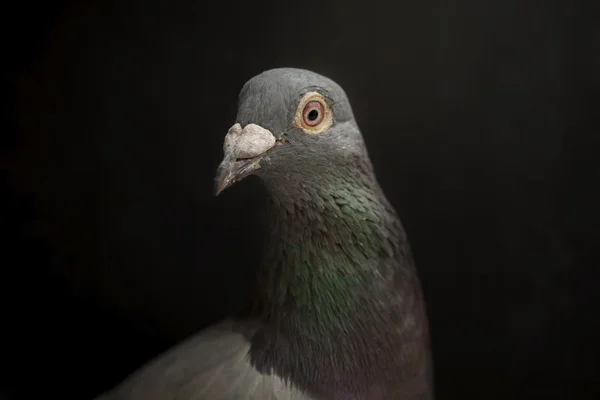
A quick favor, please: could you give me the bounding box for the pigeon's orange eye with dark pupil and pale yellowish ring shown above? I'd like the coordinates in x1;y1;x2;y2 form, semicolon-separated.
294;92;333;135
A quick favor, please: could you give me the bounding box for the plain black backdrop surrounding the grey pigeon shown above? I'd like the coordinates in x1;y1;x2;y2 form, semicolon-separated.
0;0;600;400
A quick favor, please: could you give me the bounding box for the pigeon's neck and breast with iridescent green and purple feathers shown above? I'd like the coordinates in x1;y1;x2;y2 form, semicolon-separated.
244;174;426;398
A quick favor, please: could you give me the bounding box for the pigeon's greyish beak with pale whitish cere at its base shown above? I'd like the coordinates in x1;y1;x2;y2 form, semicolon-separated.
215;124;276;196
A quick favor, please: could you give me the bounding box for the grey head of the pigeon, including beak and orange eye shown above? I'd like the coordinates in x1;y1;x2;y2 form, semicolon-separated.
216;68;364;195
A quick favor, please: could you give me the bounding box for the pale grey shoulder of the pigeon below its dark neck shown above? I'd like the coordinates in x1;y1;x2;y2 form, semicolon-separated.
97;320;317;400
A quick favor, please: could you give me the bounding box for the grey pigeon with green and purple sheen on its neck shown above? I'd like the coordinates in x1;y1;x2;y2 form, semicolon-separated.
100;68;434;400
